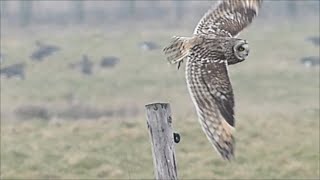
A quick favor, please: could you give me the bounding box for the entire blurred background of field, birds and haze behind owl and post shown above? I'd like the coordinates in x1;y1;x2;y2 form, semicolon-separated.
0;0;320;179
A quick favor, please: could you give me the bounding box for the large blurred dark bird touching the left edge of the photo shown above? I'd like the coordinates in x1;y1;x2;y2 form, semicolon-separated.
0;63;25;79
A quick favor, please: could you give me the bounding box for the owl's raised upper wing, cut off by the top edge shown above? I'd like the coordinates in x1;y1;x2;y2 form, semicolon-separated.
194;0;263;37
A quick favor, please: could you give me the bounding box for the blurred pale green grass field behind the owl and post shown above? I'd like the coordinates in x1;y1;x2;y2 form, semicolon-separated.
1;22;320;179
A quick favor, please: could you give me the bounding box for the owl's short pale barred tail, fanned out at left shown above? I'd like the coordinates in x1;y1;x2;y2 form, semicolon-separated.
163;36;194;64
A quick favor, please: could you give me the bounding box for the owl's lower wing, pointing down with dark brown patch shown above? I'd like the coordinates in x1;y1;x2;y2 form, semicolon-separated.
186;49;235;160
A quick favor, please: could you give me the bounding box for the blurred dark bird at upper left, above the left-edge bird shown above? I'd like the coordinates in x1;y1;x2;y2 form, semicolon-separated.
30;41;60;61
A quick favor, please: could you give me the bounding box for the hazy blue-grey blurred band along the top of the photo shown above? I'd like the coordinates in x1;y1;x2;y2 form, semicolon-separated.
0;0;319;26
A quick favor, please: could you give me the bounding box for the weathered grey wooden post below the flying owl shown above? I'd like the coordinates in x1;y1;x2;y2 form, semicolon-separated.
145;103;177;180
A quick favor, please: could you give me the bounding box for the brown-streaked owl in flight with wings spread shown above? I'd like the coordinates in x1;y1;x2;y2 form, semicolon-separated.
164;0;262;160
